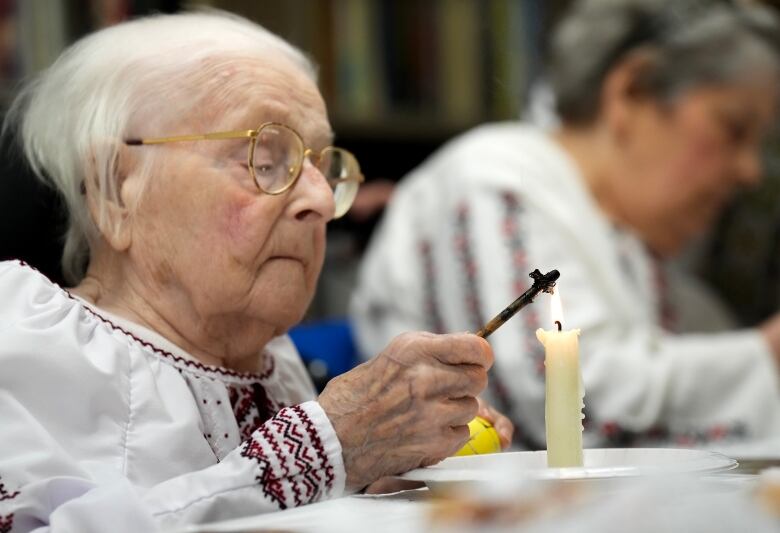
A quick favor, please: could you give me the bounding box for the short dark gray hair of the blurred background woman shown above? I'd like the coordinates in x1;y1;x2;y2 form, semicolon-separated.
548;0;780;124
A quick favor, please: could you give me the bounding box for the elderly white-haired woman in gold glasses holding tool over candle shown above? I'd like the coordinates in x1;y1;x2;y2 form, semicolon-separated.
0;14;511;532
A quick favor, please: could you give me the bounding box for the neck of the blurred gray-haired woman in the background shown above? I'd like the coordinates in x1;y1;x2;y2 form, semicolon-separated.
554;126;627;225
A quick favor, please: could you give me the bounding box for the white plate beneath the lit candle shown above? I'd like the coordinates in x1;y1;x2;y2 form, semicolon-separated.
399;448;737;483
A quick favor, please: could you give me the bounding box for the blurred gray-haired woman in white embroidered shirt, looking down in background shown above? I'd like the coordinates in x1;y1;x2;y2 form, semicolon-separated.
353;0;780;448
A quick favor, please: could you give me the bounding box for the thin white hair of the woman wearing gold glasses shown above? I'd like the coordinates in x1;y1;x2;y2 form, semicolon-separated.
4;11;317;284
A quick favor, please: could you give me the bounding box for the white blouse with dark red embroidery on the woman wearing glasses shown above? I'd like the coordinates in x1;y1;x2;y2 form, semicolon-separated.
0;261;346;533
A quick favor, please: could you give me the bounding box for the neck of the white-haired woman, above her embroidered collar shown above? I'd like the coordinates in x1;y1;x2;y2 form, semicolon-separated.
70;248;281;372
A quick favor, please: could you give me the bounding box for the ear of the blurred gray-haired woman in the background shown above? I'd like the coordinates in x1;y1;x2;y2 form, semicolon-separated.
601;50;658;144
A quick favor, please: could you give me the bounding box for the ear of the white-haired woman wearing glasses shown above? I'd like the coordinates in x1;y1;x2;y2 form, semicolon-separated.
83;144;141;252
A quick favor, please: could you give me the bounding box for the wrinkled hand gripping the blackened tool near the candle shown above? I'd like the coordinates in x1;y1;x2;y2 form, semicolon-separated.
319;333;493;489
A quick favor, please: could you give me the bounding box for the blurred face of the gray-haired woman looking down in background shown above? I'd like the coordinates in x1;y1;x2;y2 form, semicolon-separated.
616;78;777;255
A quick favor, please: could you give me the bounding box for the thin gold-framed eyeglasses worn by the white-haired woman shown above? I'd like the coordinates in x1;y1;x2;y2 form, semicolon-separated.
125;122;365;218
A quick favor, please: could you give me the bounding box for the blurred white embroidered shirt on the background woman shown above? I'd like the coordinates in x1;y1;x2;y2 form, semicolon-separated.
352;123;780;448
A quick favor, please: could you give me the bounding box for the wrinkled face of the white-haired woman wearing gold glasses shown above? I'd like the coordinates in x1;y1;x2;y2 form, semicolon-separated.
125;58;334;332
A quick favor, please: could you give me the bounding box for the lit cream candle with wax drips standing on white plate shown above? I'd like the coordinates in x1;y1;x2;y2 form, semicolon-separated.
536;288;585;468
